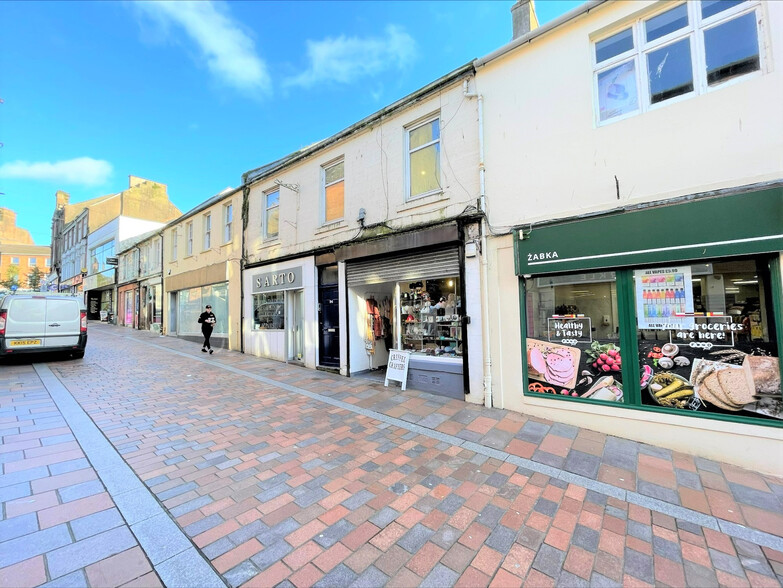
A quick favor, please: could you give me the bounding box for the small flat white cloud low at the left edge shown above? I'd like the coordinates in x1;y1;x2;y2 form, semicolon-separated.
0;157;113;186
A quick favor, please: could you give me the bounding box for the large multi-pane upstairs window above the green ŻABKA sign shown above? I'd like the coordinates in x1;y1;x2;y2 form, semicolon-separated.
593;0;761;123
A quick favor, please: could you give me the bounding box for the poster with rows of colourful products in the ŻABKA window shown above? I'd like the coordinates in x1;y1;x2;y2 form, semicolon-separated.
634;265;693;330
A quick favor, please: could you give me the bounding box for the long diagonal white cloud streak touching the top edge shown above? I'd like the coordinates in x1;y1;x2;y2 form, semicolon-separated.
130;1;272;93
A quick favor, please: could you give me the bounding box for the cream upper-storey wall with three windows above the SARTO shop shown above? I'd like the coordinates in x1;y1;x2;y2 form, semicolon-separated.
246;81;478;263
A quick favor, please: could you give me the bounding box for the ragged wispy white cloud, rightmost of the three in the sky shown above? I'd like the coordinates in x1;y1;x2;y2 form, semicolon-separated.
285;25;416;88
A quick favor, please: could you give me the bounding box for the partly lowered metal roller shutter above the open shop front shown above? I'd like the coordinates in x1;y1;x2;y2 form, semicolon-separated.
345;248;459;288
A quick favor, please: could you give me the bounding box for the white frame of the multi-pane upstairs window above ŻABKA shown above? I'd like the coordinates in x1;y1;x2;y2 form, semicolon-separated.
590;0;767;127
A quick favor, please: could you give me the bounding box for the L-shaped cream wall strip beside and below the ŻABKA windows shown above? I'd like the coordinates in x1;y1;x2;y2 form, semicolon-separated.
489;236;783;476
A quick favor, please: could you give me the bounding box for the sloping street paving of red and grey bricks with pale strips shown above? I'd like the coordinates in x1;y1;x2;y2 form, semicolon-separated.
0;323;783;588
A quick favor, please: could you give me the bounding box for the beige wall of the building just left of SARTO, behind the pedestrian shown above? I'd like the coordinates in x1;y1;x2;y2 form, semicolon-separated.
163;192;242;350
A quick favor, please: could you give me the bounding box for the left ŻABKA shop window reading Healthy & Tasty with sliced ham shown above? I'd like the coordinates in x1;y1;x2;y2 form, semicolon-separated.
527;272;625;403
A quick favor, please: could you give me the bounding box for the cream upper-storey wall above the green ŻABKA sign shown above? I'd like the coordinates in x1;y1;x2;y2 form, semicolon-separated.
476;1;783;226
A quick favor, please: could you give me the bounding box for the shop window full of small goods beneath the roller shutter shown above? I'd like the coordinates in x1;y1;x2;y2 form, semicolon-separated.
399;276;463;357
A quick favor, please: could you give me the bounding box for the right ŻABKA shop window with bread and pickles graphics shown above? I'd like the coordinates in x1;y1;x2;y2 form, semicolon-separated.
633;259;781;418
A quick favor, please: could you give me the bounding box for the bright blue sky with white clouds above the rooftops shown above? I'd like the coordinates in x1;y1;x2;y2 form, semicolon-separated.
0;0;584;245
